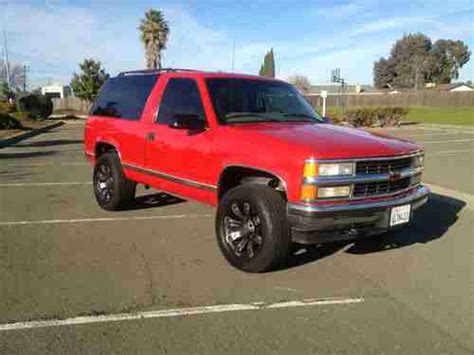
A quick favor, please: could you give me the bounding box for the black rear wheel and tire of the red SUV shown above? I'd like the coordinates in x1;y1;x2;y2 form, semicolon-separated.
93;152;137;211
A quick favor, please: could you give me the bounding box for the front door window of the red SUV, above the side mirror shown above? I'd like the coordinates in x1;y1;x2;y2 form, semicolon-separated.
156;79;206;125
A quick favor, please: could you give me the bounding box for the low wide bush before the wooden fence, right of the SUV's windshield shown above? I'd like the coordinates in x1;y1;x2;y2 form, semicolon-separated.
344;107;408;127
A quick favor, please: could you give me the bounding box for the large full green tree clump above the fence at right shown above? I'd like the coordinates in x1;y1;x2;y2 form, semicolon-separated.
374;33;470;89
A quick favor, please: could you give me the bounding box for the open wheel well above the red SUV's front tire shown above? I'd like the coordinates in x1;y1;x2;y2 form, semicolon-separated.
218;166;286;200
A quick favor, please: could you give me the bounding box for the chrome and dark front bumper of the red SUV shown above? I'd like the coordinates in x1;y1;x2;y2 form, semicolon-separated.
288;185;430;244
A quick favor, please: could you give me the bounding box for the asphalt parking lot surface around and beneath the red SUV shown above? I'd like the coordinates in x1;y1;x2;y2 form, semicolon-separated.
0;123;474;354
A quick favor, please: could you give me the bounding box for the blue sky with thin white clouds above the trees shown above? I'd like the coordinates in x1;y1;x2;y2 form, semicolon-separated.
0;0;474;87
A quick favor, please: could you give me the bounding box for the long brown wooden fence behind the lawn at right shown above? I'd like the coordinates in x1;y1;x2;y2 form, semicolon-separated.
307;91;474;107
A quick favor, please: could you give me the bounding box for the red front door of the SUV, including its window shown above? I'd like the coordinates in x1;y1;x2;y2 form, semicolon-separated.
145;78;214;196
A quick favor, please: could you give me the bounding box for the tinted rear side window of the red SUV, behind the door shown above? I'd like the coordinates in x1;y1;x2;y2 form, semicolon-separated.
91;74;158;120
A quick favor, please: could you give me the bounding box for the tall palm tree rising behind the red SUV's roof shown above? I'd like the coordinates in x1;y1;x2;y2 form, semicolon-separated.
138;9;170;69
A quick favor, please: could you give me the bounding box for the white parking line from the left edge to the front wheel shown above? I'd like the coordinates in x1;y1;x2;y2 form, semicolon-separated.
0;214;213;227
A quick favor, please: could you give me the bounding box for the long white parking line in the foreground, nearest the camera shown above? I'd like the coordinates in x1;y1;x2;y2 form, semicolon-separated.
0;298;364;331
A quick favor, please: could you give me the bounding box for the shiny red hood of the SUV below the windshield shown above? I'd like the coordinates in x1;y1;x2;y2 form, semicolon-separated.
233;122;420;159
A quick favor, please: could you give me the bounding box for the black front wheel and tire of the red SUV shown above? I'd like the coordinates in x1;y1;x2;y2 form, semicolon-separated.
216;184;290;272
